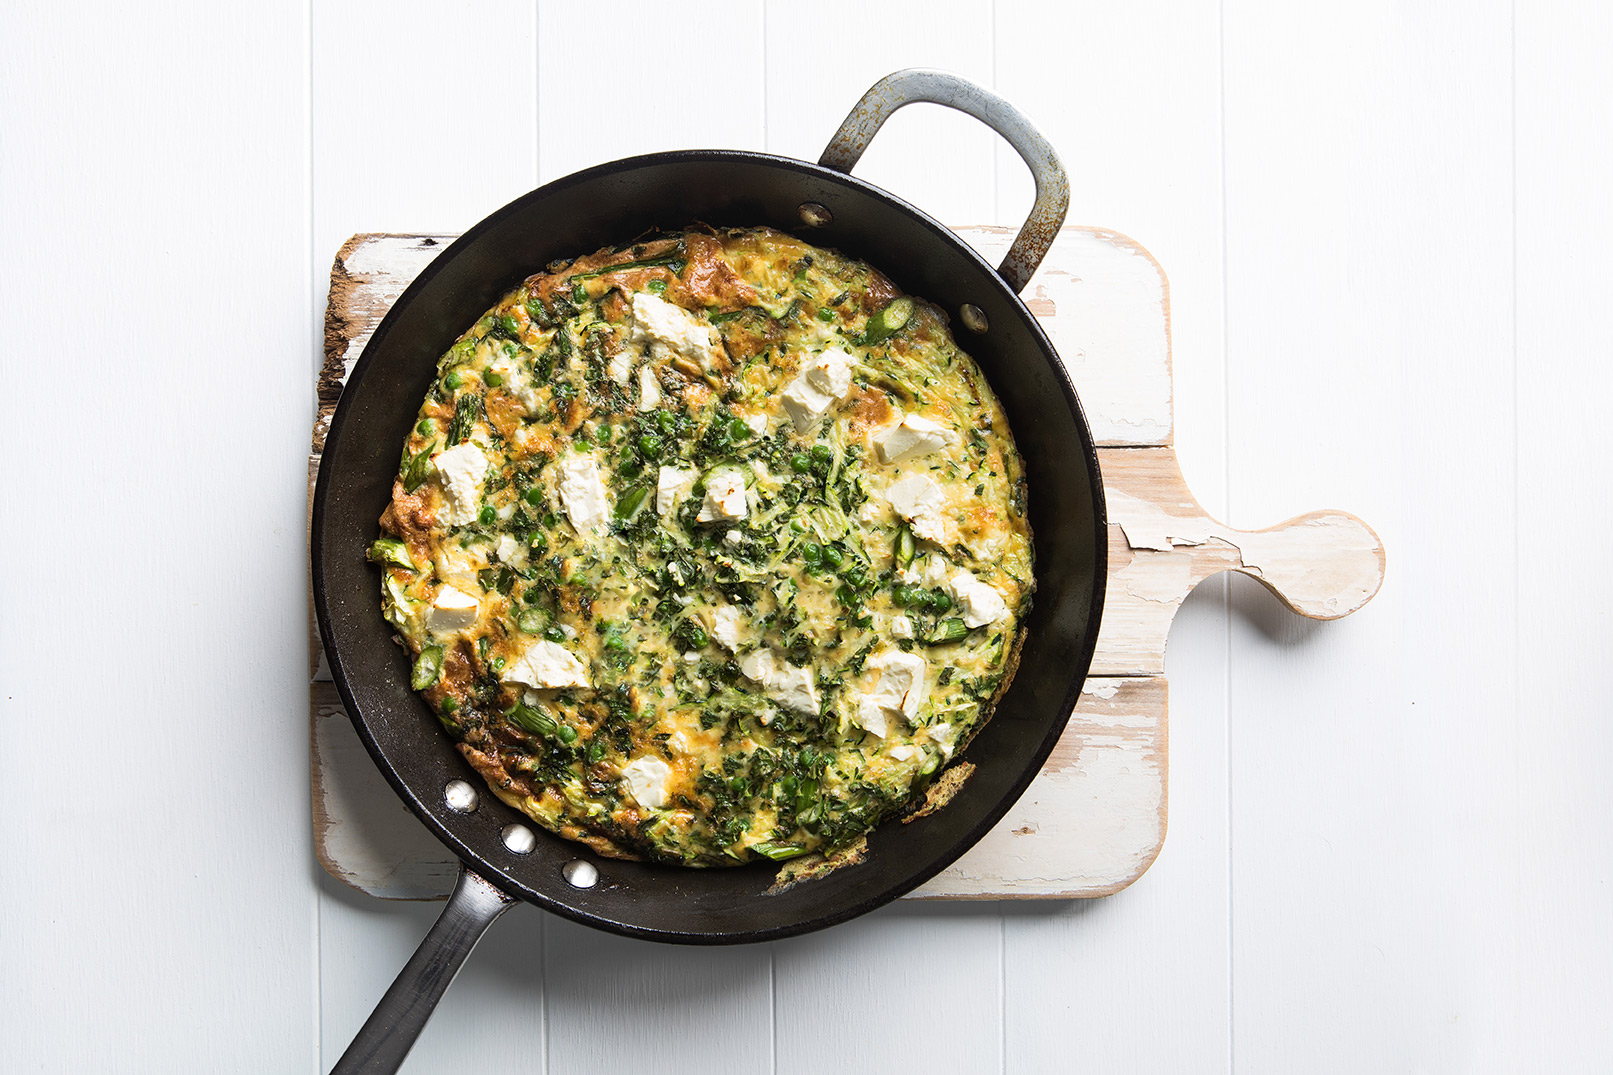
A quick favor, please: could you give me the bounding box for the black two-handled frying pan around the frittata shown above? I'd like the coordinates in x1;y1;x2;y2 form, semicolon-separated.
310;69;1107;1072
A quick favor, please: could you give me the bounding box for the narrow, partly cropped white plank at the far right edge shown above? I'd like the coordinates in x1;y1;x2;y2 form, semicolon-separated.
1515;0;1613;1072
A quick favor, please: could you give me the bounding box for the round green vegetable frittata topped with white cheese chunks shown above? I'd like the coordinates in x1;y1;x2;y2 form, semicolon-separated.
369;228;1034;865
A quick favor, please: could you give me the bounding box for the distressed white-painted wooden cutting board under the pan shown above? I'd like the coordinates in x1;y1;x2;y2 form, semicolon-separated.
308;228;1384;899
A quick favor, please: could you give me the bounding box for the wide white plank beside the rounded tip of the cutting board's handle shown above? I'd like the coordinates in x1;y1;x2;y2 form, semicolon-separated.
1226;0;1516;1075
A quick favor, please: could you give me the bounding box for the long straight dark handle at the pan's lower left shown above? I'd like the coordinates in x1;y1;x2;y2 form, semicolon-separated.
331;867;515;1075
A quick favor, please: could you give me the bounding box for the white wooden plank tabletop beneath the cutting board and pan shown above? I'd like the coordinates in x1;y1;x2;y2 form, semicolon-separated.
0;0;1613;1075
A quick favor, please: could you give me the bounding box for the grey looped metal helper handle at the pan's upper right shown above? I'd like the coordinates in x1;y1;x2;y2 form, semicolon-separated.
818;68;1069;294
